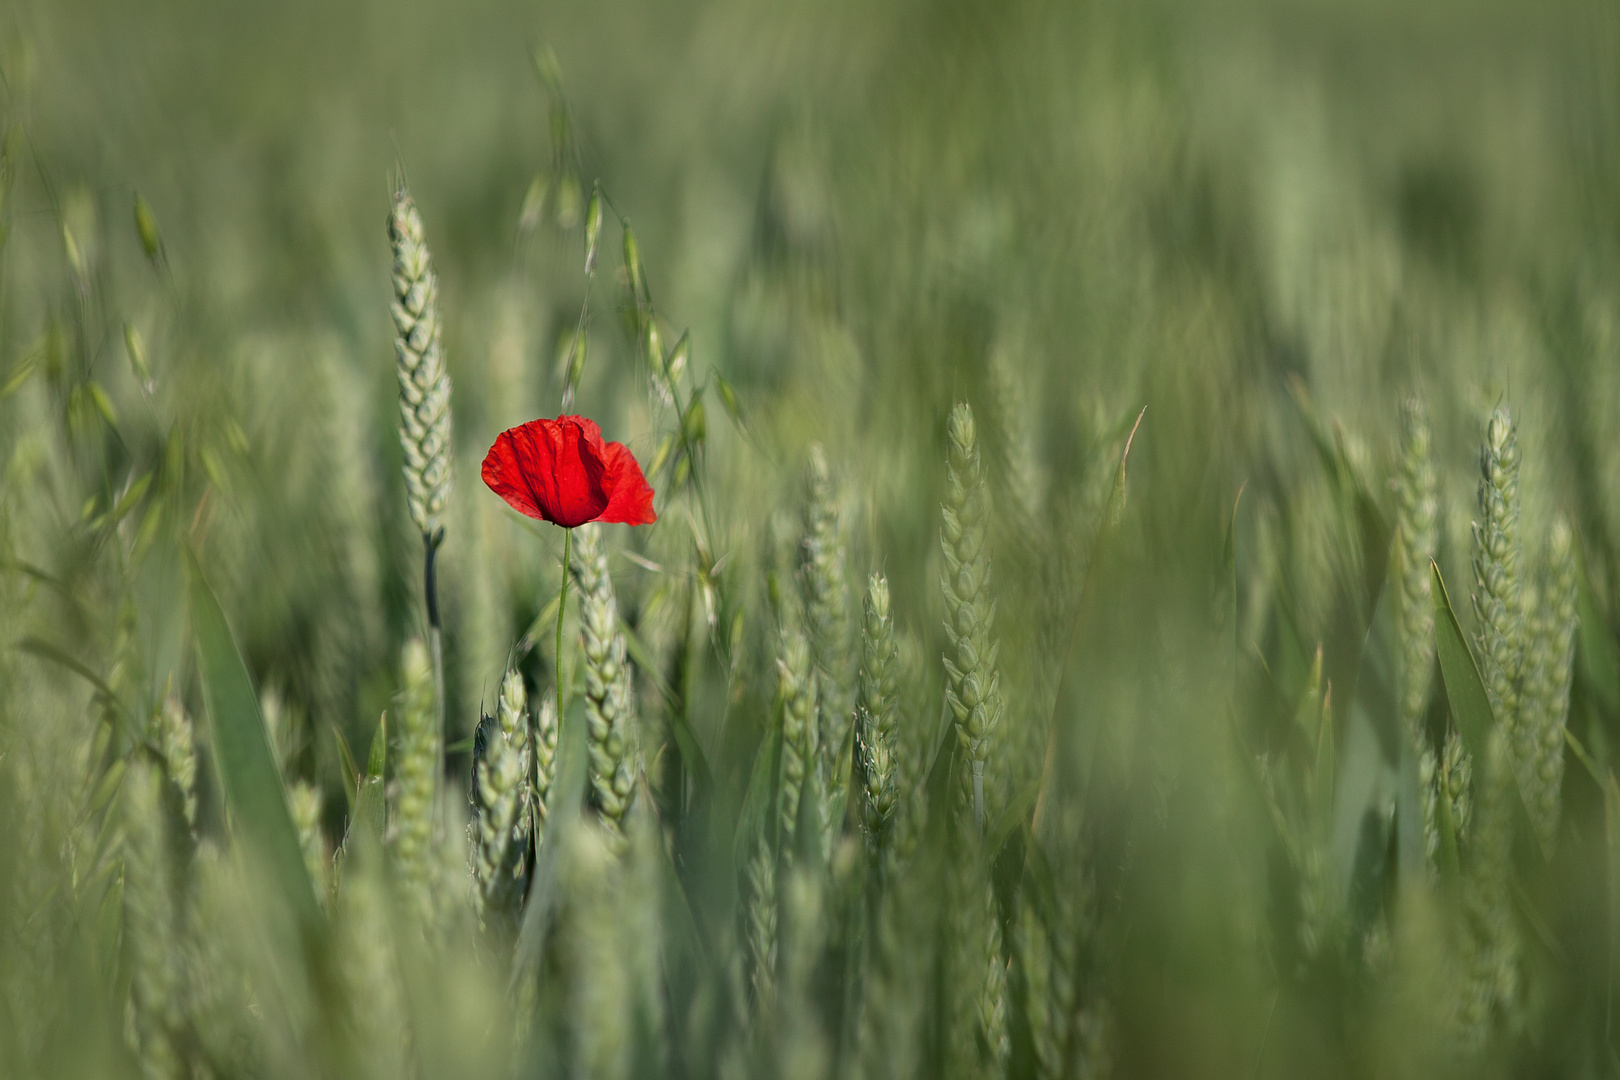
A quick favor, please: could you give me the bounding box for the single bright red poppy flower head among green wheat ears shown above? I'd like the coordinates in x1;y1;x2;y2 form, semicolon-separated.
483;416;658;529
